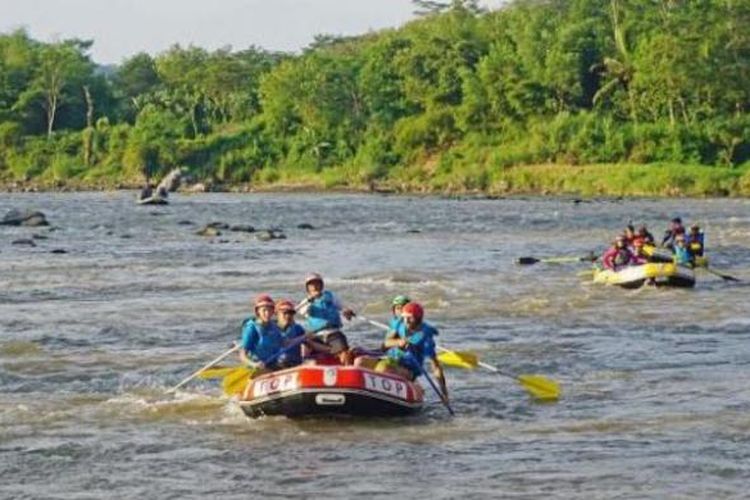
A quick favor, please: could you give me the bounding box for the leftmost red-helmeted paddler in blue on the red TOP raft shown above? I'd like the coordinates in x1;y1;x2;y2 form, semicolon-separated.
239;294;284;375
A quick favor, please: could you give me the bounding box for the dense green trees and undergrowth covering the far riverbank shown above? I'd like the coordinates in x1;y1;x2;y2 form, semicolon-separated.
0;0;750;194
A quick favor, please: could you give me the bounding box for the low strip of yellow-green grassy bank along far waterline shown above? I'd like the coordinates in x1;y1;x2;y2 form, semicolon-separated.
0;164;750;198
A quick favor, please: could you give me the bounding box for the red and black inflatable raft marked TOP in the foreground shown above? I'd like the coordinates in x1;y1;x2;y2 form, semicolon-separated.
240;365;424;418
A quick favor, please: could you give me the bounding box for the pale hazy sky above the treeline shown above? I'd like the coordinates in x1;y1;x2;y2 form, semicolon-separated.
0;0;503;64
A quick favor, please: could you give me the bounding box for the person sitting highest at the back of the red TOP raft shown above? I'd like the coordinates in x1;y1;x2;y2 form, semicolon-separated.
299;273;355;365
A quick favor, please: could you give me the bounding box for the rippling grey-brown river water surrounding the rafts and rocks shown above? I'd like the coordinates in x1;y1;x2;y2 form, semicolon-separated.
0;192;750;499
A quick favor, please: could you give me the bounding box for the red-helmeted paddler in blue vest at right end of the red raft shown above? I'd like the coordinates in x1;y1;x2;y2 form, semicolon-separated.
382;302;448;401
